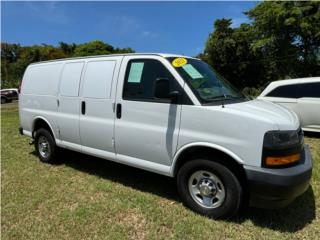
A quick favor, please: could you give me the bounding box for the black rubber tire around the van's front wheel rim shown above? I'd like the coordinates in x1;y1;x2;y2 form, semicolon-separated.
177;159;243;219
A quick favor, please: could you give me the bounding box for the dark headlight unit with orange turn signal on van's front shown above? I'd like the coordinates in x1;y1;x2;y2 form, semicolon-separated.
262;129;303;167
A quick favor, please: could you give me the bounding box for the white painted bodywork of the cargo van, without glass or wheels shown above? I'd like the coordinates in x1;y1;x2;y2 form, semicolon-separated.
19;54;299;176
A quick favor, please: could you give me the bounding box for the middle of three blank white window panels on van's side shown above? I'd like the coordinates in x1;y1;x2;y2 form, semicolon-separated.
60;62;84;97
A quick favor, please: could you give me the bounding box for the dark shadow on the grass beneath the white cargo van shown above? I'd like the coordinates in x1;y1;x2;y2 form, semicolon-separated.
33;150;315;232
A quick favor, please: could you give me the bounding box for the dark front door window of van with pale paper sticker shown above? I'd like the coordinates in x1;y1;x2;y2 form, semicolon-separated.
123;59;182;102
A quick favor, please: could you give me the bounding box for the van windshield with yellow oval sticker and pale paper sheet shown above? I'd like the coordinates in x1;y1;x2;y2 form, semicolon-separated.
167;57;245;103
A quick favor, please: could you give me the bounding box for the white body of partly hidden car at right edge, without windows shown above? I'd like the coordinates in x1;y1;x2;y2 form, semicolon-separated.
258;77;320;132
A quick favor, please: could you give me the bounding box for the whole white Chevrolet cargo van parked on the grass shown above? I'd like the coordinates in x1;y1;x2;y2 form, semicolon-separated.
19;54;312;218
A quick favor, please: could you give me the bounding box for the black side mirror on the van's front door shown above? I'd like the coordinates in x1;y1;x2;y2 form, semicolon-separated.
154;78;180;101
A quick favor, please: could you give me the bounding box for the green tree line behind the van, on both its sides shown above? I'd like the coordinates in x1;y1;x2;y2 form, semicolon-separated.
1;1;320;94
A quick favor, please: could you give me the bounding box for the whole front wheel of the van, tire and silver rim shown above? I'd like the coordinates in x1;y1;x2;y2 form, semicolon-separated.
177;159;242;218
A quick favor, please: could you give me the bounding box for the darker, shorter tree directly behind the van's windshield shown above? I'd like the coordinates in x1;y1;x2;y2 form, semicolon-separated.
202;19;261;88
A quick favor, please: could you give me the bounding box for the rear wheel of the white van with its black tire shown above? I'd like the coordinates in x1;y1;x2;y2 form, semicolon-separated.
35;128;57;163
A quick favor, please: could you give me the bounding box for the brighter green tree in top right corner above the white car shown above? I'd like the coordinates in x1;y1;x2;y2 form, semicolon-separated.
247;1;320;78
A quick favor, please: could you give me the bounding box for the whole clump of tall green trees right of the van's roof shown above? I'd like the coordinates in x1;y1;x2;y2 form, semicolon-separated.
204;1;320;88
